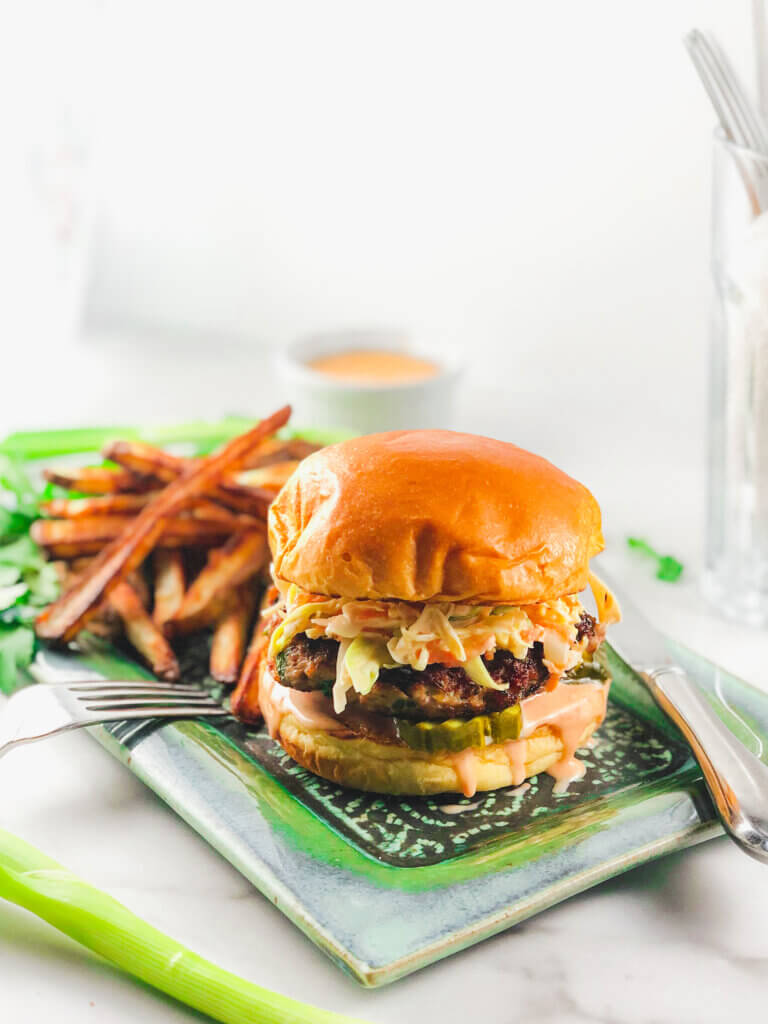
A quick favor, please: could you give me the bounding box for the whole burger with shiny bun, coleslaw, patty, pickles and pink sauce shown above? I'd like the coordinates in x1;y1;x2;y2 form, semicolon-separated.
233;430;618;797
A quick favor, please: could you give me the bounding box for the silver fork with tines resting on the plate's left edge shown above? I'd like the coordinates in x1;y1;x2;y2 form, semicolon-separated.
0;679;228;757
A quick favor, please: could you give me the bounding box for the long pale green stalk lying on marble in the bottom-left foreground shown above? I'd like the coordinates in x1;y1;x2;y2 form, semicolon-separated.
0;829;370;1024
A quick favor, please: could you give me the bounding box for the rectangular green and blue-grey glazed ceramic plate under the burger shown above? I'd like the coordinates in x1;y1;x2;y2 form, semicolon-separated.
35;640;768;985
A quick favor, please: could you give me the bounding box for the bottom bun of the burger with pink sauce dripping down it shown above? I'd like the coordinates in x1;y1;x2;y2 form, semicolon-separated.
260;660;607;797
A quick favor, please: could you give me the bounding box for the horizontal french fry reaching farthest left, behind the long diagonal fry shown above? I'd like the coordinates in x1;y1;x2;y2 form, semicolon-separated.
30;515;231;558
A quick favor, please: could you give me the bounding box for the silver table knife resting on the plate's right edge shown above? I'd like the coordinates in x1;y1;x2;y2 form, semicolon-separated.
601;568;768;864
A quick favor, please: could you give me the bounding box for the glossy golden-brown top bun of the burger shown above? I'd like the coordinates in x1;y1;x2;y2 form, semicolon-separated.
269;430;603;604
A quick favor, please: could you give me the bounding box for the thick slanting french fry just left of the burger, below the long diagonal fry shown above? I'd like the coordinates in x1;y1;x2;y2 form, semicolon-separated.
166;530;268;633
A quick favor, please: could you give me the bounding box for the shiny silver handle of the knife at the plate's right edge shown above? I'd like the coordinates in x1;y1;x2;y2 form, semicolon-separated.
644;666;768;864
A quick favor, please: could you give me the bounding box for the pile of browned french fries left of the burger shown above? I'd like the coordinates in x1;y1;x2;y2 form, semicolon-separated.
32;407;316;704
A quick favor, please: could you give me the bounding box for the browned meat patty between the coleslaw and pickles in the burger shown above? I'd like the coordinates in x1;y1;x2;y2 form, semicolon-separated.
275;613;601;721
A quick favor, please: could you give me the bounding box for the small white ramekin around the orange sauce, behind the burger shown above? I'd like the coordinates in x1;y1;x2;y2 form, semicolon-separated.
278;330;461;434
